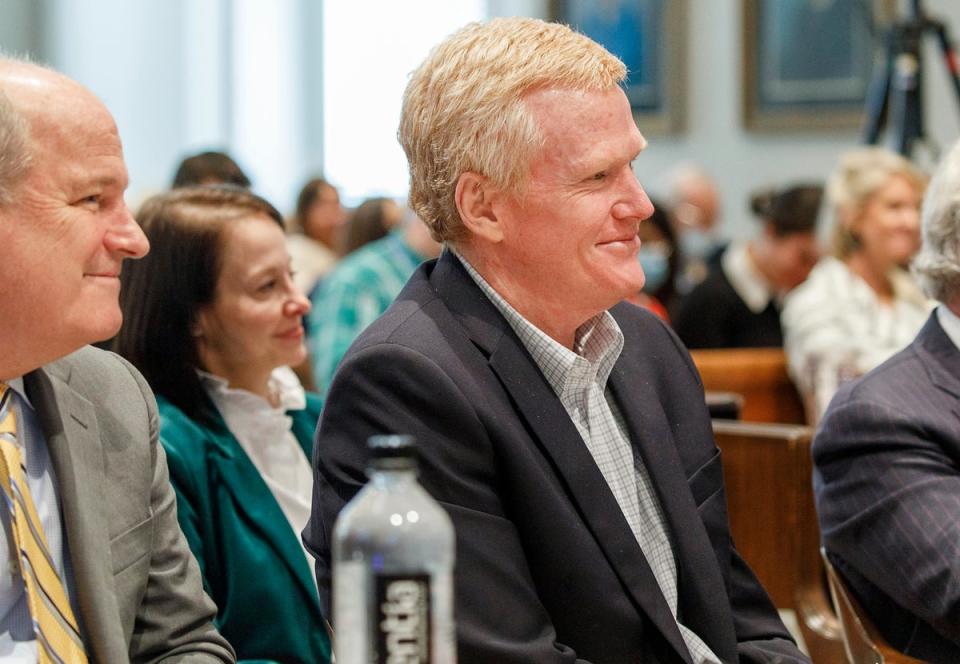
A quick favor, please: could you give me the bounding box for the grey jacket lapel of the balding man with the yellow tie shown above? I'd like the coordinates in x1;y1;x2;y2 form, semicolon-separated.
24;367;127;662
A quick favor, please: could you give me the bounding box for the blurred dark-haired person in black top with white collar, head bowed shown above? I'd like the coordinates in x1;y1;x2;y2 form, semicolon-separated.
674;185;823;348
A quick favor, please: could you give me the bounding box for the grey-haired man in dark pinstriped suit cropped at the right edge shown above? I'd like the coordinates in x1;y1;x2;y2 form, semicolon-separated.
813;137;960;662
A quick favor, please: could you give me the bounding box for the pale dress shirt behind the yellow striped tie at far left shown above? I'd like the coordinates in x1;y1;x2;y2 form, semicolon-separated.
0;378;79;664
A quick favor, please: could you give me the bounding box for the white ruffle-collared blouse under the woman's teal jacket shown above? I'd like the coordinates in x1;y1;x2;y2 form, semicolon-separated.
197;367;313;568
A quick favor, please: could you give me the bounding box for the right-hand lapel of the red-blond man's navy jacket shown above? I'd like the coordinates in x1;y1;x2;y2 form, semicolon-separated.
610;362;737;661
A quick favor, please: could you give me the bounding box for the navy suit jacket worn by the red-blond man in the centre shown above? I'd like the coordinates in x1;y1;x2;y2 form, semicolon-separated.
304;253;807;664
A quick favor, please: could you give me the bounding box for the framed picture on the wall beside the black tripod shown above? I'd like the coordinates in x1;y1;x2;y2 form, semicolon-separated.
742;0;890;131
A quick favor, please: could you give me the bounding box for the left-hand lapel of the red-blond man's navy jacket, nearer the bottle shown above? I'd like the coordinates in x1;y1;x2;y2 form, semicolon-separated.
431;252;690;663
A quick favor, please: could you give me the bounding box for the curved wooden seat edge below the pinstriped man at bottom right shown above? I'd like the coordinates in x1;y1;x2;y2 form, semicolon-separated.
820;549;922;664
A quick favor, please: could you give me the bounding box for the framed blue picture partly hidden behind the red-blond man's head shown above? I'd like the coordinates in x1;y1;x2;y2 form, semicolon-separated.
550;0;687;134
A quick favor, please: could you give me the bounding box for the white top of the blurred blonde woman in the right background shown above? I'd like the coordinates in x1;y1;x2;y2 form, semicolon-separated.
781;257;934;420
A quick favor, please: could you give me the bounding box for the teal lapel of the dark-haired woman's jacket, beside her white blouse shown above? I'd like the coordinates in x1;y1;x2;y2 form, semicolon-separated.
203;414;319;611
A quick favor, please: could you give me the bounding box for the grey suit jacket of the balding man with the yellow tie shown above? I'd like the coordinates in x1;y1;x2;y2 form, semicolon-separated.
24;348;234;664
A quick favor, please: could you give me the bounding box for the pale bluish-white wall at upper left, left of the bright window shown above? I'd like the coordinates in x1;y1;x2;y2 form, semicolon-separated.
0;0;322;208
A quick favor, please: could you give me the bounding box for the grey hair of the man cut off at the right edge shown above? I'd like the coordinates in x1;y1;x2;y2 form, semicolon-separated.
912;141;960;303
